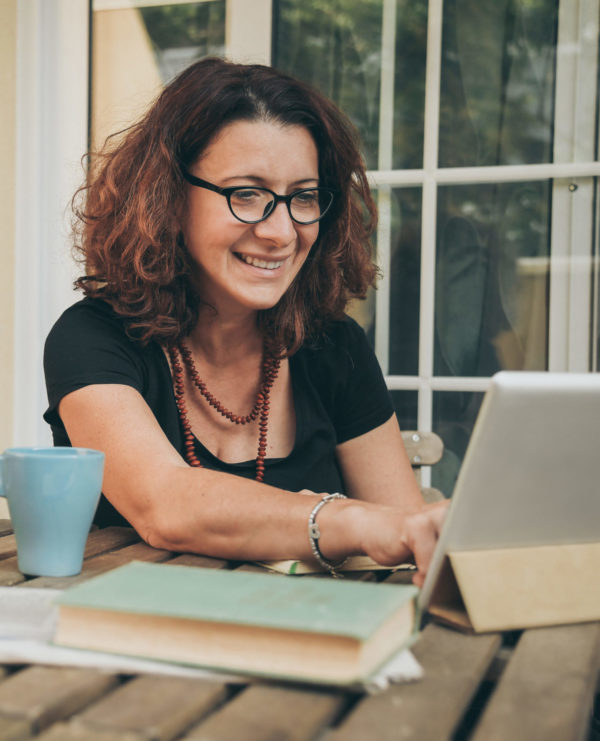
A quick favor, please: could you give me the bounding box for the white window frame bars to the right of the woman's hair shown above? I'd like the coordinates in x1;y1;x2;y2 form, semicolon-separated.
368;0;600;485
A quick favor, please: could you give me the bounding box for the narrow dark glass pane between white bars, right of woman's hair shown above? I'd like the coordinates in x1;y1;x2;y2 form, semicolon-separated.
389;188;421;376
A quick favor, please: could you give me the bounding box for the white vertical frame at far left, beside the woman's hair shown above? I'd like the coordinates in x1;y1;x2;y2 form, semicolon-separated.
13;0;88;445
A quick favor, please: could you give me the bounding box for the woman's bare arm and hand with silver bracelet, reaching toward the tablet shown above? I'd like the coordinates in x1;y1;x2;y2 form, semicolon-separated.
59;385;446;580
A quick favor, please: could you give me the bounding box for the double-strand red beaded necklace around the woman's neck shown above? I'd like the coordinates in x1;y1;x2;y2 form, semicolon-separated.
167;342;280;481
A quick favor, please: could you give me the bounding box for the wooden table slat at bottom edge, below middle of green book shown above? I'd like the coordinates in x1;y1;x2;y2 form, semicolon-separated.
182;684;344;741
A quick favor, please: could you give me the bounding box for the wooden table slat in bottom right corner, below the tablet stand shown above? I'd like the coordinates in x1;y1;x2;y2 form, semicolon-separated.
473;623;600;741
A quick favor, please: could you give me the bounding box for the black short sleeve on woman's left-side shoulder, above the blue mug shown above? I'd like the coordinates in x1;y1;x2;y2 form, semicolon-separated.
44;299;145;425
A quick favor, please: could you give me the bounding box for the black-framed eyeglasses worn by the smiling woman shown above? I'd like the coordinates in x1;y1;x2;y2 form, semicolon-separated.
181;168;335;224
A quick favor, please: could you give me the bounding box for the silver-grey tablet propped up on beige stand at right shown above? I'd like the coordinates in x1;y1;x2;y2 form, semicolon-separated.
419;371;600;609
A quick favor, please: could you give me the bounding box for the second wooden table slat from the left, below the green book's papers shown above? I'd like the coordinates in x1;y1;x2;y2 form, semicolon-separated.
73;675;228;741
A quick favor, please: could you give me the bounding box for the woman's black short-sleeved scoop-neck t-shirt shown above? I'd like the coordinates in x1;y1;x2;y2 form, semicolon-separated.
44;298;393;526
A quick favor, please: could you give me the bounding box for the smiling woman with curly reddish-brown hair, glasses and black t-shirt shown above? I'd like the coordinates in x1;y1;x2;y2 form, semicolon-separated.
45;59;445;583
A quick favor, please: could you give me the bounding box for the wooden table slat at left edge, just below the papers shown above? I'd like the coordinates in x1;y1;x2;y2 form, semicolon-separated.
0;666;118;731
